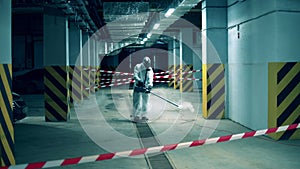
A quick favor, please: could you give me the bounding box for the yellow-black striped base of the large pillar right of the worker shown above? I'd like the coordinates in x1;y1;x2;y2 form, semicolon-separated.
202;63;225;119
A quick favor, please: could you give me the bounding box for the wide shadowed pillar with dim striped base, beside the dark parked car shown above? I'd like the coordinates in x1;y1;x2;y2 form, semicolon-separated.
44;8;70;121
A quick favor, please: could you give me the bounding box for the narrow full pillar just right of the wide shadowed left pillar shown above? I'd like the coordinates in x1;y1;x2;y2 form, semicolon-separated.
69;22;83;103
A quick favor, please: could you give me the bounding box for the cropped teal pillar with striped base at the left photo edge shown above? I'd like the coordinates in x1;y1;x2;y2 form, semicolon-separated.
0;1;16;166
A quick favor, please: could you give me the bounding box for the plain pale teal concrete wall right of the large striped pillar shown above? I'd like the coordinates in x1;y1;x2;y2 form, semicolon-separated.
227;0;300;129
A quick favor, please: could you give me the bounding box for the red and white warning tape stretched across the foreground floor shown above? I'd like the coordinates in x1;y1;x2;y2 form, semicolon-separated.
0;123;300;169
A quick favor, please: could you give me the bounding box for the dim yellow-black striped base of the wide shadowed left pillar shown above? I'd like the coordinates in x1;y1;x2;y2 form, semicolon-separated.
44;66;70;121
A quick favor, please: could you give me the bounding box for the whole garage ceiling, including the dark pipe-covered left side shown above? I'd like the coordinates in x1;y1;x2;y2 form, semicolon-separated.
12;0;201;48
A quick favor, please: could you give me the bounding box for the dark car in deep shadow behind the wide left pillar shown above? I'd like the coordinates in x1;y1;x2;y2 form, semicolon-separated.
12;69;44;94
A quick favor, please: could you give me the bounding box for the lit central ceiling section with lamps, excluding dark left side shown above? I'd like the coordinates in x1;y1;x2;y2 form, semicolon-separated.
100;0;201;45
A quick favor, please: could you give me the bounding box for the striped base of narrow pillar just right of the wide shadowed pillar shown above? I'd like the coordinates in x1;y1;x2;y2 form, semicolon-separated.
69;66;83;103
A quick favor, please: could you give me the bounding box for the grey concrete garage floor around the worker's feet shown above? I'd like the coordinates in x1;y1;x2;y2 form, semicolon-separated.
15;88;300;169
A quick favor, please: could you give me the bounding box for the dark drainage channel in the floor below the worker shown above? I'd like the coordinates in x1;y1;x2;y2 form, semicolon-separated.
135;123;175;169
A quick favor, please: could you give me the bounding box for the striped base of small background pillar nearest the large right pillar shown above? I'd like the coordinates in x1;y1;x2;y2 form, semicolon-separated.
180;65;193;92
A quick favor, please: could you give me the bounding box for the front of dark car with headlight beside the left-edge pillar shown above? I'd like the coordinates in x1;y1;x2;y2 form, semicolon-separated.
12;92;28;122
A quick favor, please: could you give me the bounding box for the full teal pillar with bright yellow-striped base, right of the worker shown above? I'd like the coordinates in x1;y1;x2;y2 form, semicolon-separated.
202;0;227;119
